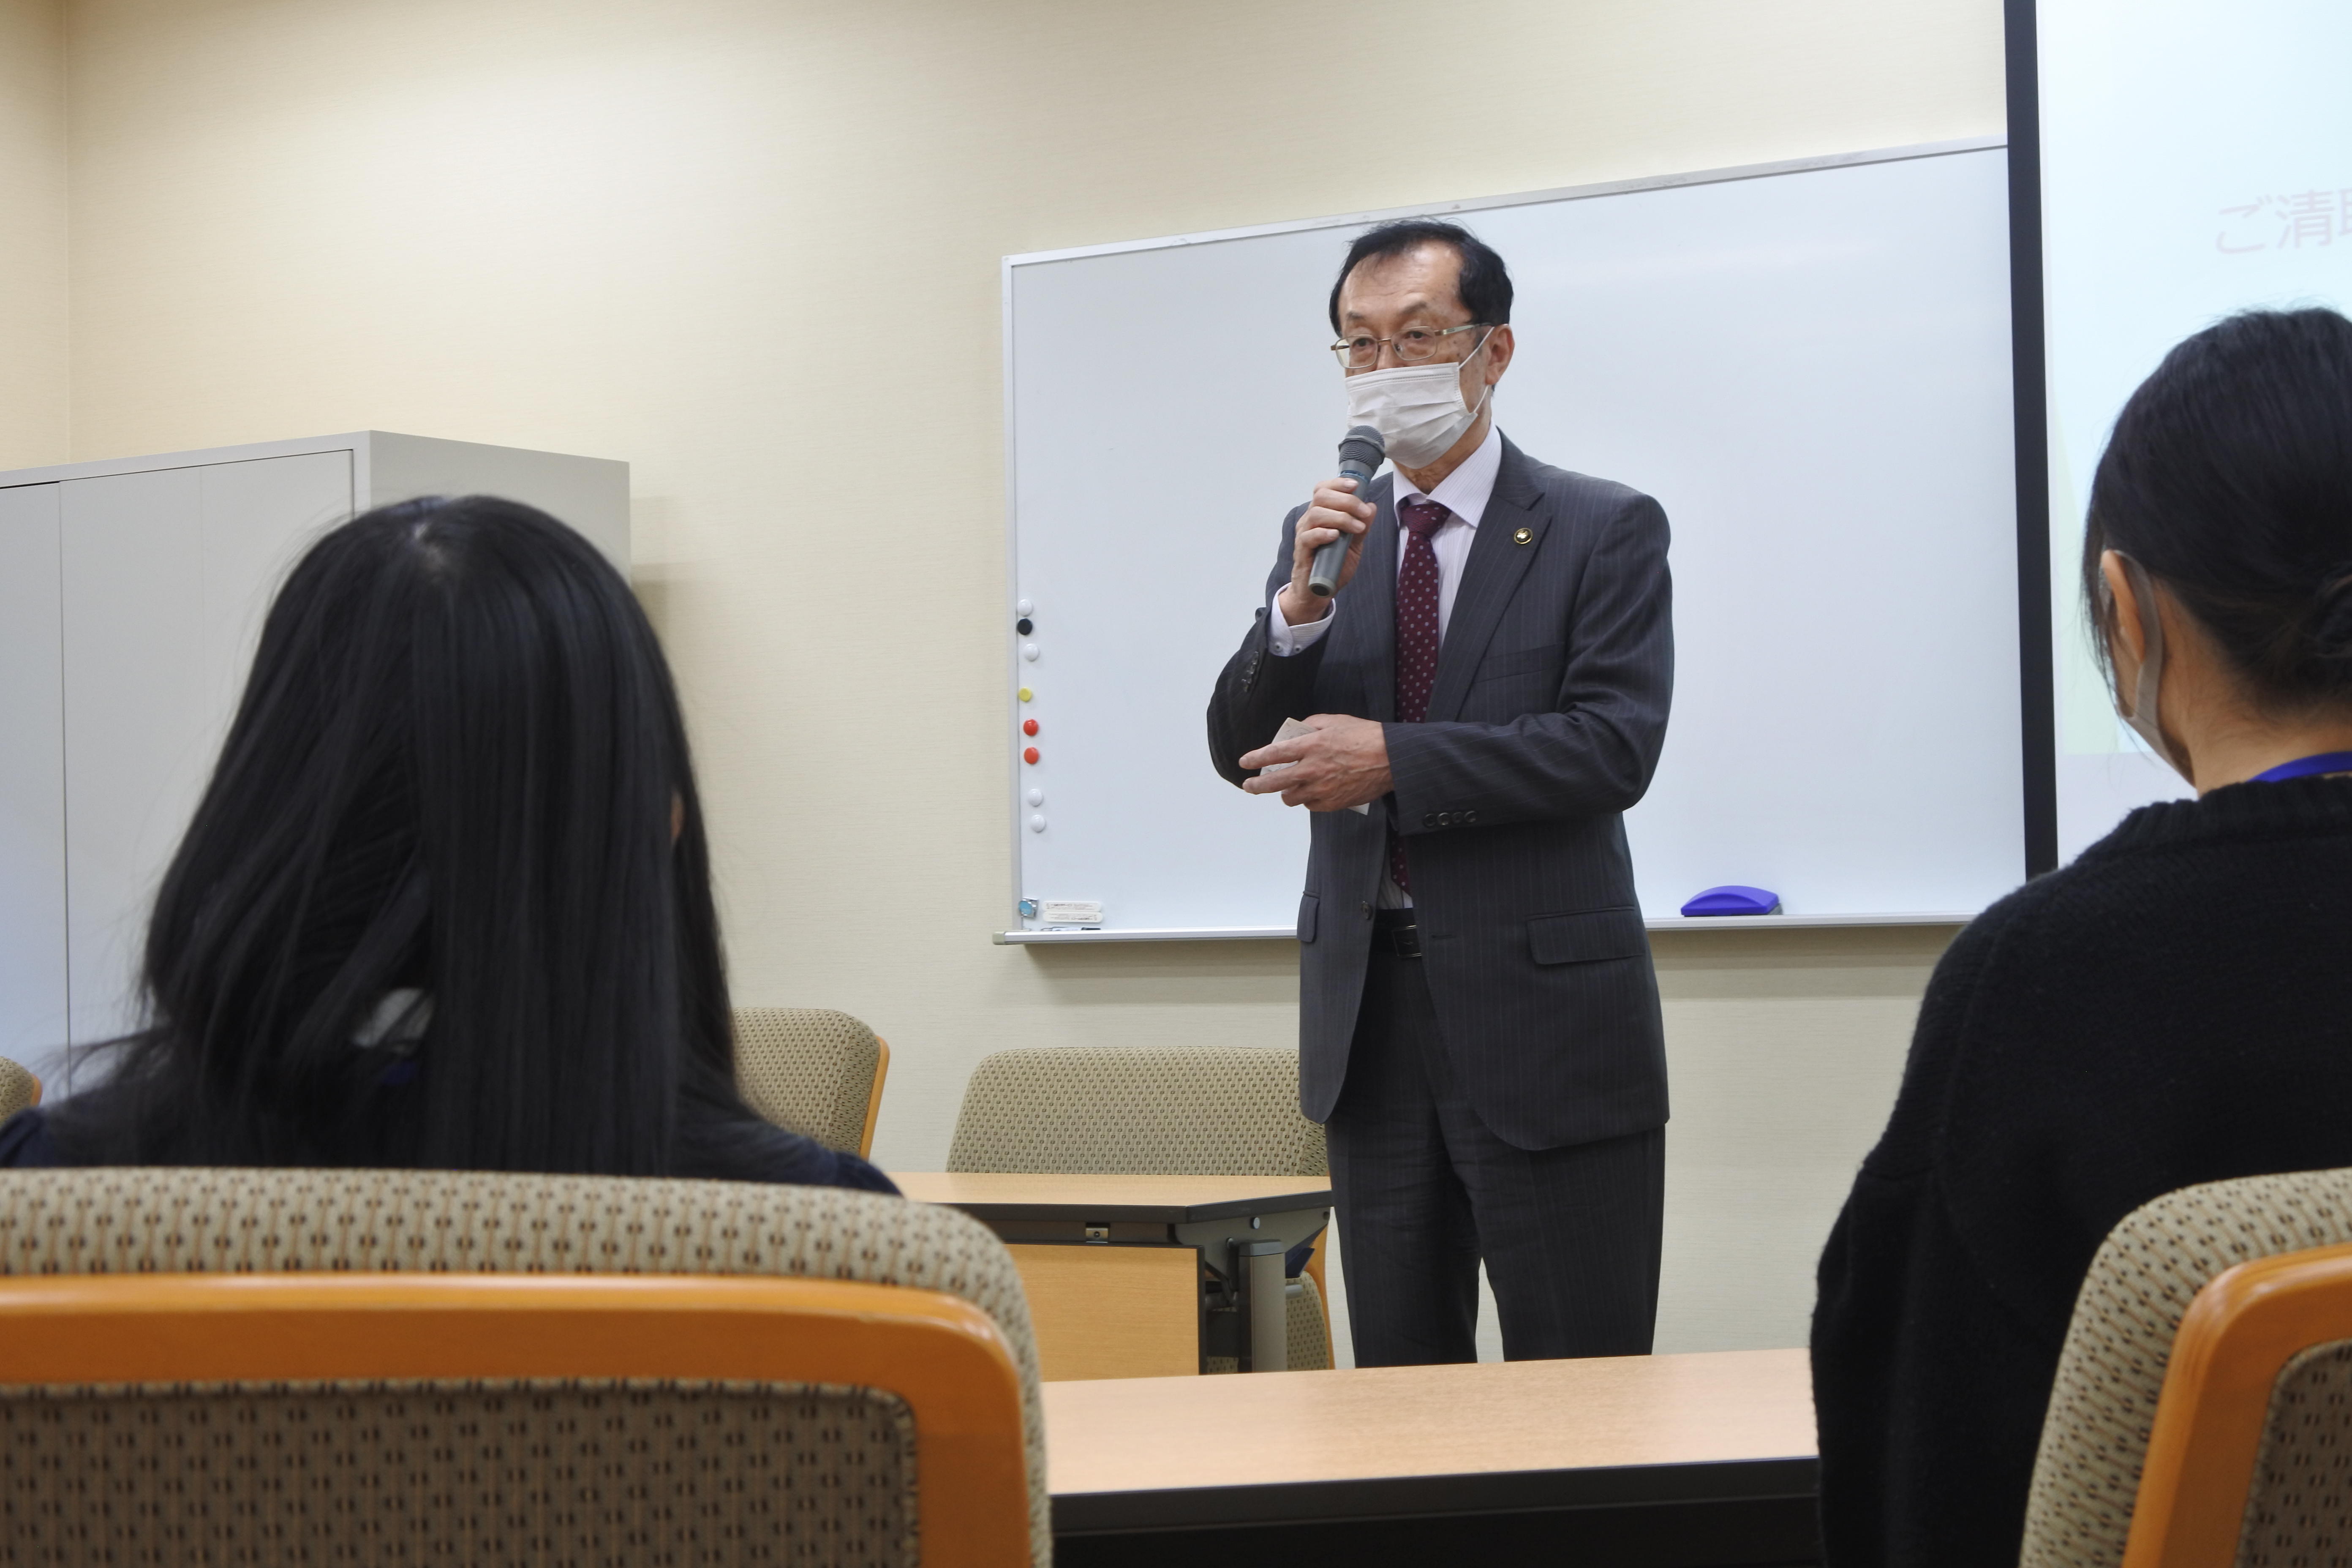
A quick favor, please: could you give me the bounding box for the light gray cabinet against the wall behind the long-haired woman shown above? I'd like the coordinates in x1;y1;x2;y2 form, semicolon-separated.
0;430;628;1091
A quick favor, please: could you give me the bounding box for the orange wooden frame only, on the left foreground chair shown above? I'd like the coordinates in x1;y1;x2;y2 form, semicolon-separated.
0;1274;1030;1568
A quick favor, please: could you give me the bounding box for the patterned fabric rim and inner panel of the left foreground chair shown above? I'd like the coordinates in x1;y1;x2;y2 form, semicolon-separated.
0;1168;1051;1568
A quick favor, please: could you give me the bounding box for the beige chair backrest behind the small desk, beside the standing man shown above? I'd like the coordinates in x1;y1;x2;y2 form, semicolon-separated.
948;1046;1329;1176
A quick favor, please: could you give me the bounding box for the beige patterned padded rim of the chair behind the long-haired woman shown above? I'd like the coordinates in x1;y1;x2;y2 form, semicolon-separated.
0;1168;1051;1565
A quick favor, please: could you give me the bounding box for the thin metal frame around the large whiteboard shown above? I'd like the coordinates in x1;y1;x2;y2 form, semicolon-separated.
990;132;2013;947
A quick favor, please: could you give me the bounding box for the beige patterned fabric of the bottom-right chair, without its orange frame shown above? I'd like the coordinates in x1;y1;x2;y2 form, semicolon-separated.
2020;1171;2352;1568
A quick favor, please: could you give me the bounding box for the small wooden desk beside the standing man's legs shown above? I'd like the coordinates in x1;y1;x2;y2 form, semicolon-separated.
891;1171;1331;1382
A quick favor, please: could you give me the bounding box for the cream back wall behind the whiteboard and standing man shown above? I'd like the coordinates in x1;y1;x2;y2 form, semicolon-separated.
46;0;2001;1342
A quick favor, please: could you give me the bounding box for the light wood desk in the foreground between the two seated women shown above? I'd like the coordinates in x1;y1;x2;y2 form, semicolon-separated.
1044;1349;1818;1568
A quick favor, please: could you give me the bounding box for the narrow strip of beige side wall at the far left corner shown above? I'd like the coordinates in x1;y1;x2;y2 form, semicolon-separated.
0;0;71;470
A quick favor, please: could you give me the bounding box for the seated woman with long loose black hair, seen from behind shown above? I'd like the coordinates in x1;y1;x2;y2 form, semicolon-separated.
0;496;894;1192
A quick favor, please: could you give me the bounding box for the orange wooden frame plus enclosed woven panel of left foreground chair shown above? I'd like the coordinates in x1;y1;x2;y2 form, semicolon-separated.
0;1274;1032;1568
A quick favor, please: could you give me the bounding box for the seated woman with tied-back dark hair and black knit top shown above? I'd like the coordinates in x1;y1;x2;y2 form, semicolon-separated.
1813;310;2352;1568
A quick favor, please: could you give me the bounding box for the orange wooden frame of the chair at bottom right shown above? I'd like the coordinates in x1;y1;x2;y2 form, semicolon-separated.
2124;1246;2352;1568
